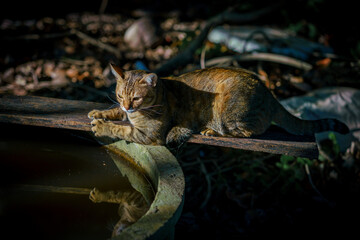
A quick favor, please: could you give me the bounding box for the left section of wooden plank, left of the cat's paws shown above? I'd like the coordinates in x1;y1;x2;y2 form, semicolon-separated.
0;96;101;131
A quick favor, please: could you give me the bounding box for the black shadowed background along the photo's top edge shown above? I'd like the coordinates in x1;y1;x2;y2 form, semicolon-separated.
0;0;360;56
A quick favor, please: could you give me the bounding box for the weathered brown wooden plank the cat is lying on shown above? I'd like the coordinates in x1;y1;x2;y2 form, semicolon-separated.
0;96;318;159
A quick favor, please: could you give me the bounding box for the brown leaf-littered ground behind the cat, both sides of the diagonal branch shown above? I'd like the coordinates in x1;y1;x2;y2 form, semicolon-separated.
0;10;354;101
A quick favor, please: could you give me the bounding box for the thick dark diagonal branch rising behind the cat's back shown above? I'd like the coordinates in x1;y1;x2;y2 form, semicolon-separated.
154;4;281;75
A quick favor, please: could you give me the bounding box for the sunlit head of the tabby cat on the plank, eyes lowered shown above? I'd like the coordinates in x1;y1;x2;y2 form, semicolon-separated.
110;64;158;113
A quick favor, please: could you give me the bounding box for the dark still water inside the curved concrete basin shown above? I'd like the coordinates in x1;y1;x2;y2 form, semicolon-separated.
0;125;150;239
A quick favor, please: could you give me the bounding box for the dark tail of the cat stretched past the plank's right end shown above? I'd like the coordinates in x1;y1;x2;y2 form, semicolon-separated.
273;103;349;135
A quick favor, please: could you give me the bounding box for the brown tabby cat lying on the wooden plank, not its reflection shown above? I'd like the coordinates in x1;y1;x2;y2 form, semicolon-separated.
88;64;349;145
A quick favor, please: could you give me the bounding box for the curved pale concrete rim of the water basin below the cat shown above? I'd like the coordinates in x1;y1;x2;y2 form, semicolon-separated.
106;141;185;239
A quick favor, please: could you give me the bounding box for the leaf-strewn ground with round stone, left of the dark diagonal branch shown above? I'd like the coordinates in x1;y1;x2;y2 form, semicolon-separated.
0;13;191;95
